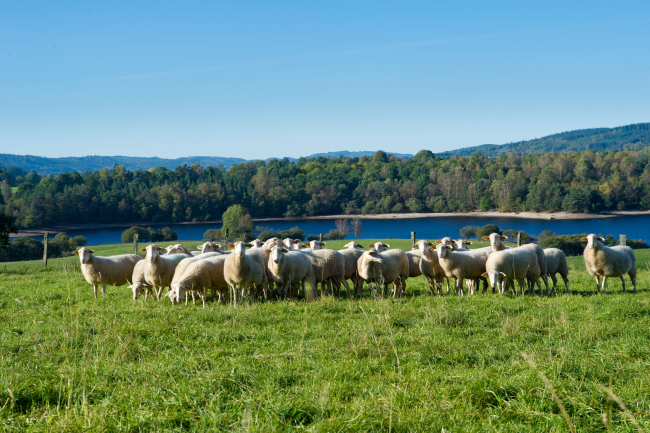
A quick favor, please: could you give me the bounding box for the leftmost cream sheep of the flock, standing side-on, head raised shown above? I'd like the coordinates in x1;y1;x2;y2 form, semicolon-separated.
72;247;142;298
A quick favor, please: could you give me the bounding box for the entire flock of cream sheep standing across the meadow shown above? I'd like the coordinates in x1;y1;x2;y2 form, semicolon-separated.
74;233;636;307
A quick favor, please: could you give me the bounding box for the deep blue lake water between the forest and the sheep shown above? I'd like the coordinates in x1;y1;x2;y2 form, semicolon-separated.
26;215;650;245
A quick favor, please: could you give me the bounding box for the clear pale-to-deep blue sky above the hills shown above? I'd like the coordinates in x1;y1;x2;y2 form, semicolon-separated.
0;0;650;159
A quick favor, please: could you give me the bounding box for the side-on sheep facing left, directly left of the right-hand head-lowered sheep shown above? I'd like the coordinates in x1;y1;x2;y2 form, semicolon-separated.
436;244;491;295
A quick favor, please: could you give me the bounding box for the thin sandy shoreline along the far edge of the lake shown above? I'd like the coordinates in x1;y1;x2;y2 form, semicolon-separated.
9;210;650;238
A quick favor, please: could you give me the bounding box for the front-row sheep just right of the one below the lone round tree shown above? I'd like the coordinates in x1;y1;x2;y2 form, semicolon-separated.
267;245;316;300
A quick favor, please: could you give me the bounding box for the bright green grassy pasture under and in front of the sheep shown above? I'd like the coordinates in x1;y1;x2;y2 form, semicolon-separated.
0;240;650;432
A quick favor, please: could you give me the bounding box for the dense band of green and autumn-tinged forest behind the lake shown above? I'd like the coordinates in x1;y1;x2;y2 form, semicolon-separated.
0;149;650;228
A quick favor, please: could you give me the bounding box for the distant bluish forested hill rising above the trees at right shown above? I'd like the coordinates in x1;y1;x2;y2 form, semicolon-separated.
436;123;650;158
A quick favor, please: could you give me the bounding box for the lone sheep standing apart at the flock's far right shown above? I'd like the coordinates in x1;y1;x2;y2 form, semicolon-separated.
581;234;636;294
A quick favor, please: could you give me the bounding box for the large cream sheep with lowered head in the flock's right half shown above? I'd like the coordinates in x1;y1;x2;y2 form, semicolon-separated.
482;248;542;295
